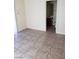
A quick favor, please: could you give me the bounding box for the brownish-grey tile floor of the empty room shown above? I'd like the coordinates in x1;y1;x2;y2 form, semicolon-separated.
14;29;65;59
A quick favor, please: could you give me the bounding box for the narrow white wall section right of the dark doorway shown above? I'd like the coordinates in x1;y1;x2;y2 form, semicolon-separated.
56;0;65;34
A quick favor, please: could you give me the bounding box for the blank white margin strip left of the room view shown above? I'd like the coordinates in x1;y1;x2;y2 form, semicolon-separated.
0;0;14;59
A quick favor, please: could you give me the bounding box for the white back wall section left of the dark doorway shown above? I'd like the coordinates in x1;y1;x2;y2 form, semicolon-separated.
25;0;46;31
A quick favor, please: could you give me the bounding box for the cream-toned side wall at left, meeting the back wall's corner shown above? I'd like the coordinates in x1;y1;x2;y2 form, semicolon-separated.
15;0;26;32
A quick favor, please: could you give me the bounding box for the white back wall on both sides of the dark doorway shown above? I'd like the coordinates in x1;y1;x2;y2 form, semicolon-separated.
25;0;65;34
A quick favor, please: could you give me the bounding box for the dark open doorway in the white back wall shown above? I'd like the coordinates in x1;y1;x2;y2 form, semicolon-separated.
46;1;56;33
